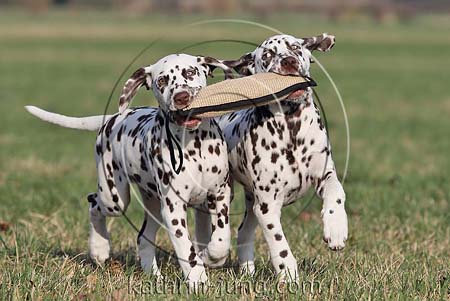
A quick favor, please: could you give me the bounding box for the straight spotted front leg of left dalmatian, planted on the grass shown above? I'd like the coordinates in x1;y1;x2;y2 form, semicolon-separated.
161;193;208;288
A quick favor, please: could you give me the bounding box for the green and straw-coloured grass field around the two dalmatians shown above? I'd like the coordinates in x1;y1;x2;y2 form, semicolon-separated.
0;11;450;300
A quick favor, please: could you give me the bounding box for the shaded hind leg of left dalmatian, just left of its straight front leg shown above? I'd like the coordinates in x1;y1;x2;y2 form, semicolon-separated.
137;191;162;277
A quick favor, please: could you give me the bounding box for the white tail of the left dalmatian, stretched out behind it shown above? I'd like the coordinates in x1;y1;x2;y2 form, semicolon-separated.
25;106;112;131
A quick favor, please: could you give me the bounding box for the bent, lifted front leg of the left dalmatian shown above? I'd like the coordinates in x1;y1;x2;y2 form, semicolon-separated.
200;183;231;267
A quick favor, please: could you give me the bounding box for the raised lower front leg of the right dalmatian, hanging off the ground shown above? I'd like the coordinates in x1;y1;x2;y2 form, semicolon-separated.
316;169;348;250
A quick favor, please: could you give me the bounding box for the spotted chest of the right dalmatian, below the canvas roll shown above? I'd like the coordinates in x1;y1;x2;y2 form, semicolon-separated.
227;106;327;203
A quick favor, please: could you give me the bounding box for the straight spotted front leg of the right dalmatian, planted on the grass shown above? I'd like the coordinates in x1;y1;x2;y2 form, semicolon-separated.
253;191;298;282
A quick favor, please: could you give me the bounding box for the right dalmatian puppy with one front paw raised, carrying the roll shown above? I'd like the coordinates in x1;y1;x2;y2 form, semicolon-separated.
219;34;347;281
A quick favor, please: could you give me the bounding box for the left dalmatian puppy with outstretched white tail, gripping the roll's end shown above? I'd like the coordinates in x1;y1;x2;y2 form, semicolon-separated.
27;54;231;285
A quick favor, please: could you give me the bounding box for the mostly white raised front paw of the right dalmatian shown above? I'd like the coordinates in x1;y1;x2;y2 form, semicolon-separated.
322;209;348;251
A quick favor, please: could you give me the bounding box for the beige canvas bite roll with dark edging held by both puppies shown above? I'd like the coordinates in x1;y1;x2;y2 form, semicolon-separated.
178;73;317;118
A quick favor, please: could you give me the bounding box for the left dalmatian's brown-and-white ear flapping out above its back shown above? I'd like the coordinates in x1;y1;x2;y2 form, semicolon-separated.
119;66;152;113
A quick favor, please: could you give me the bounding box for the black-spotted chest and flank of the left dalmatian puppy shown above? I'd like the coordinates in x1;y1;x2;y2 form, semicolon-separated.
114;116;228;203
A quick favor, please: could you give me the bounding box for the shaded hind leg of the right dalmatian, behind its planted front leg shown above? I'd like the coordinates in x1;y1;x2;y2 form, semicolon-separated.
237;191;258;275
